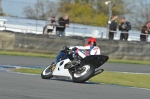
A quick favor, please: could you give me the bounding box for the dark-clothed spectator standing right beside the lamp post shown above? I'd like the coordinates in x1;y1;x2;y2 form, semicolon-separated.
109;14;118;40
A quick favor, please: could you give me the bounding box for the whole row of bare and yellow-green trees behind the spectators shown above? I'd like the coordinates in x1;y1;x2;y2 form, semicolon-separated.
0;0;150;28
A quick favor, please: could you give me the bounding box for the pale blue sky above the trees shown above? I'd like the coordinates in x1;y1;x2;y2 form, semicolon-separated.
2;0;150;17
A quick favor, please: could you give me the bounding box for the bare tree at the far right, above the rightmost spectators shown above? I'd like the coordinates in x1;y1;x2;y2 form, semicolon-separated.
128;0;150;29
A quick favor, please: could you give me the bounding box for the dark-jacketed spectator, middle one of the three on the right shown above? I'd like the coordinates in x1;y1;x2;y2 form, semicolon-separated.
119;17;131;41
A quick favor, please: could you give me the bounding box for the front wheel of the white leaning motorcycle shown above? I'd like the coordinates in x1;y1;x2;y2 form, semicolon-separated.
41;65;53;79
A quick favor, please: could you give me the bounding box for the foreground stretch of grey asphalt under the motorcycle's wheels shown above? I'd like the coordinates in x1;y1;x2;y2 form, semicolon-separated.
0;71;150;99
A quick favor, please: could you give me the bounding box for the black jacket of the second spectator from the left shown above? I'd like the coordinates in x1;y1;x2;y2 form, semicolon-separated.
56;17;69;31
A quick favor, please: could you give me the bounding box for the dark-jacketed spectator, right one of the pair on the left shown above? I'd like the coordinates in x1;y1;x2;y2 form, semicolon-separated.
56;14;69;36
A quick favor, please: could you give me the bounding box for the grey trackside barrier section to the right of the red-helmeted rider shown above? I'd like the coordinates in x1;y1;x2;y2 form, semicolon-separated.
98;40;150;60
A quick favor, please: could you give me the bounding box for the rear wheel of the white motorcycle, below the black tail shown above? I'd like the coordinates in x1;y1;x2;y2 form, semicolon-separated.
72;65;95;83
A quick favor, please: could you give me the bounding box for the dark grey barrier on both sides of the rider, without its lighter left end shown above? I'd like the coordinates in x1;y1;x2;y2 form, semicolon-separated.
0;33;150;60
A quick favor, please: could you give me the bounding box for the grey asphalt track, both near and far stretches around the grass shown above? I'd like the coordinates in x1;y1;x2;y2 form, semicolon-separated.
0;55;150;99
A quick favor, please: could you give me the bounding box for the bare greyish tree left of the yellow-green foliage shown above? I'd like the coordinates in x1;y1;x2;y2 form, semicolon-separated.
23;0;57;19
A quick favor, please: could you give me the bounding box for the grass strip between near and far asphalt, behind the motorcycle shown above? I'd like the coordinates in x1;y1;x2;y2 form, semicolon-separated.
14;69;150;89
